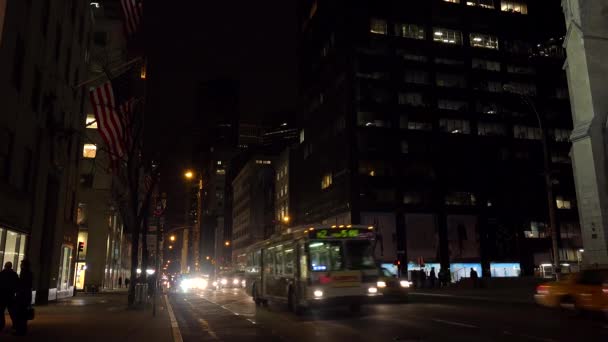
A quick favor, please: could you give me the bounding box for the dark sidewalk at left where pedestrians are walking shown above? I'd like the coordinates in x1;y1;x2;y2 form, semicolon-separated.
0;291;173;342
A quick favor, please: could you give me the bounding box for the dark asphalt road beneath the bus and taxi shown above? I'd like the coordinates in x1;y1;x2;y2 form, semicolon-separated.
170;289;608;342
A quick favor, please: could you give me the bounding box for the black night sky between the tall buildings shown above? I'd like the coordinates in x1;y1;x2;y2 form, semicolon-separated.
145;0;297;226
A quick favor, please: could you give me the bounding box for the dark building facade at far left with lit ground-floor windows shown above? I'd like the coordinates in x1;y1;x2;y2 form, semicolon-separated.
0;1;92;303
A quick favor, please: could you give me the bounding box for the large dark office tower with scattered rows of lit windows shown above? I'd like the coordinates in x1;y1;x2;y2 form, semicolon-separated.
294;0;581;279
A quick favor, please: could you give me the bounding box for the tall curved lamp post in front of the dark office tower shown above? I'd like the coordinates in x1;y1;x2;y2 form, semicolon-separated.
503;85;561;280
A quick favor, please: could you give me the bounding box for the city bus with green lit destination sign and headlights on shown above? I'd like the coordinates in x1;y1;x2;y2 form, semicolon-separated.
236;225;379;314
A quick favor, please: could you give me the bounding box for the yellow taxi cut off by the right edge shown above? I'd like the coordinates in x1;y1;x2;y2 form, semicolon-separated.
534;269;608;313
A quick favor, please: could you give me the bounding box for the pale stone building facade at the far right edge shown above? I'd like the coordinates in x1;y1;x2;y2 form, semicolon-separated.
562;0;608;267
